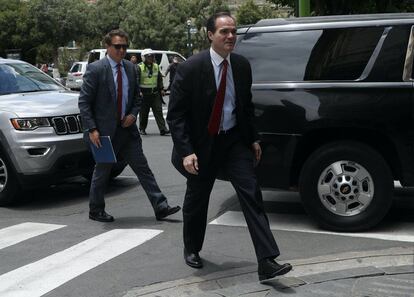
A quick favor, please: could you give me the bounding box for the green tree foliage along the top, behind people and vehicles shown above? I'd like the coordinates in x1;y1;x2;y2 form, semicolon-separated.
0;0;414;67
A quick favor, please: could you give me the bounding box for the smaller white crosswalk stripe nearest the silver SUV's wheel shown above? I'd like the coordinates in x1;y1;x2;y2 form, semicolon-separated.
0;222;66;250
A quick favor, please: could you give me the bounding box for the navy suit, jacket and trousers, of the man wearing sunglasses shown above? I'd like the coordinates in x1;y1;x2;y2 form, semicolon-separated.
79;58;167;213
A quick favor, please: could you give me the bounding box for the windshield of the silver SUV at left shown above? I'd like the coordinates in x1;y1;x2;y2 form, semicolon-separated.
0;63;63;95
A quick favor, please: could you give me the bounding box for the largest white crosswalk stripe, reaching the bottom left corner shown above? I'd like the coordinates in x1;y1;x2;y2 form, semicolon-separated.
0;229;162;297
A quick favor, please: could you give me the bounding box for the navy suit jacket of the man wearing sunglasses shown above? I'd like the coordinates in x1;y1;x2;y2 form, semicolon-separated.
78;57;142;141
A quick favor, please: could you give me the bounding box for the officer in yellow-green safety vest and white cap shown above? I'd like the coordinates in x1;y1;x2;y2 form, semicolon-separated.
138;49;170;135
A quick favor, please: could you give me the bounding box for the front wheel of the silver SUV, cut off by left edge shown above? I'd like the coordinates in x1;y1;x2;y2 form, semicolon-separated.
0;154;18;206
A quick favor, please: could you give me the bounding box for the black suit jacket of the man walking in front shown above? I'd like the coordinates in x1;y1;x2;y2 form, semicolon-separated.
167;50;259;177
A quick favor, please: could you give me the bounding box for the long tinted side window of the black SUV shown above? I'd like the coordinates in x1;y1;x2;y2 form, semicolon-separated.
237;27;384;82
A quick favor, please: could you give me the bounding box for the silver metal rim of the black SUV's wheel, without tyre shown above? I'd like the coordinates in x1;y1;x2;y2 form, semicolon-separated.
318;161;374;216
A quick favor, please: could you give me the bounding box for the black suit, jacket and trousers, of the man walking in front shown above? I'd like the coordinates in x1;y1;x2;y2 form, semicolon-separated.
167;50;279;260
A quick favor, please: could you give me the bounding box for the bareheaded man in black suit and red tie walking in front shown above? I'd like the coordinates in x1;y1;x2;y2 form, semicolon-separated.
167;12;292;281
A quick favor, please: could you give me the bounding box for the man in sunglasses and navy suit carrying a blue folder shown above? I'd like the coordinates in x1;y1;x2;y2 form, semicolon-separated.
79;30;180;222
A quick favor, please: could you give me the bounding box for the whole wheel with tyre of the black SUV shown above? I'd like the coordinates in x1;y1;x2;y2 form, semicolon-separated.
299;141;393;231
